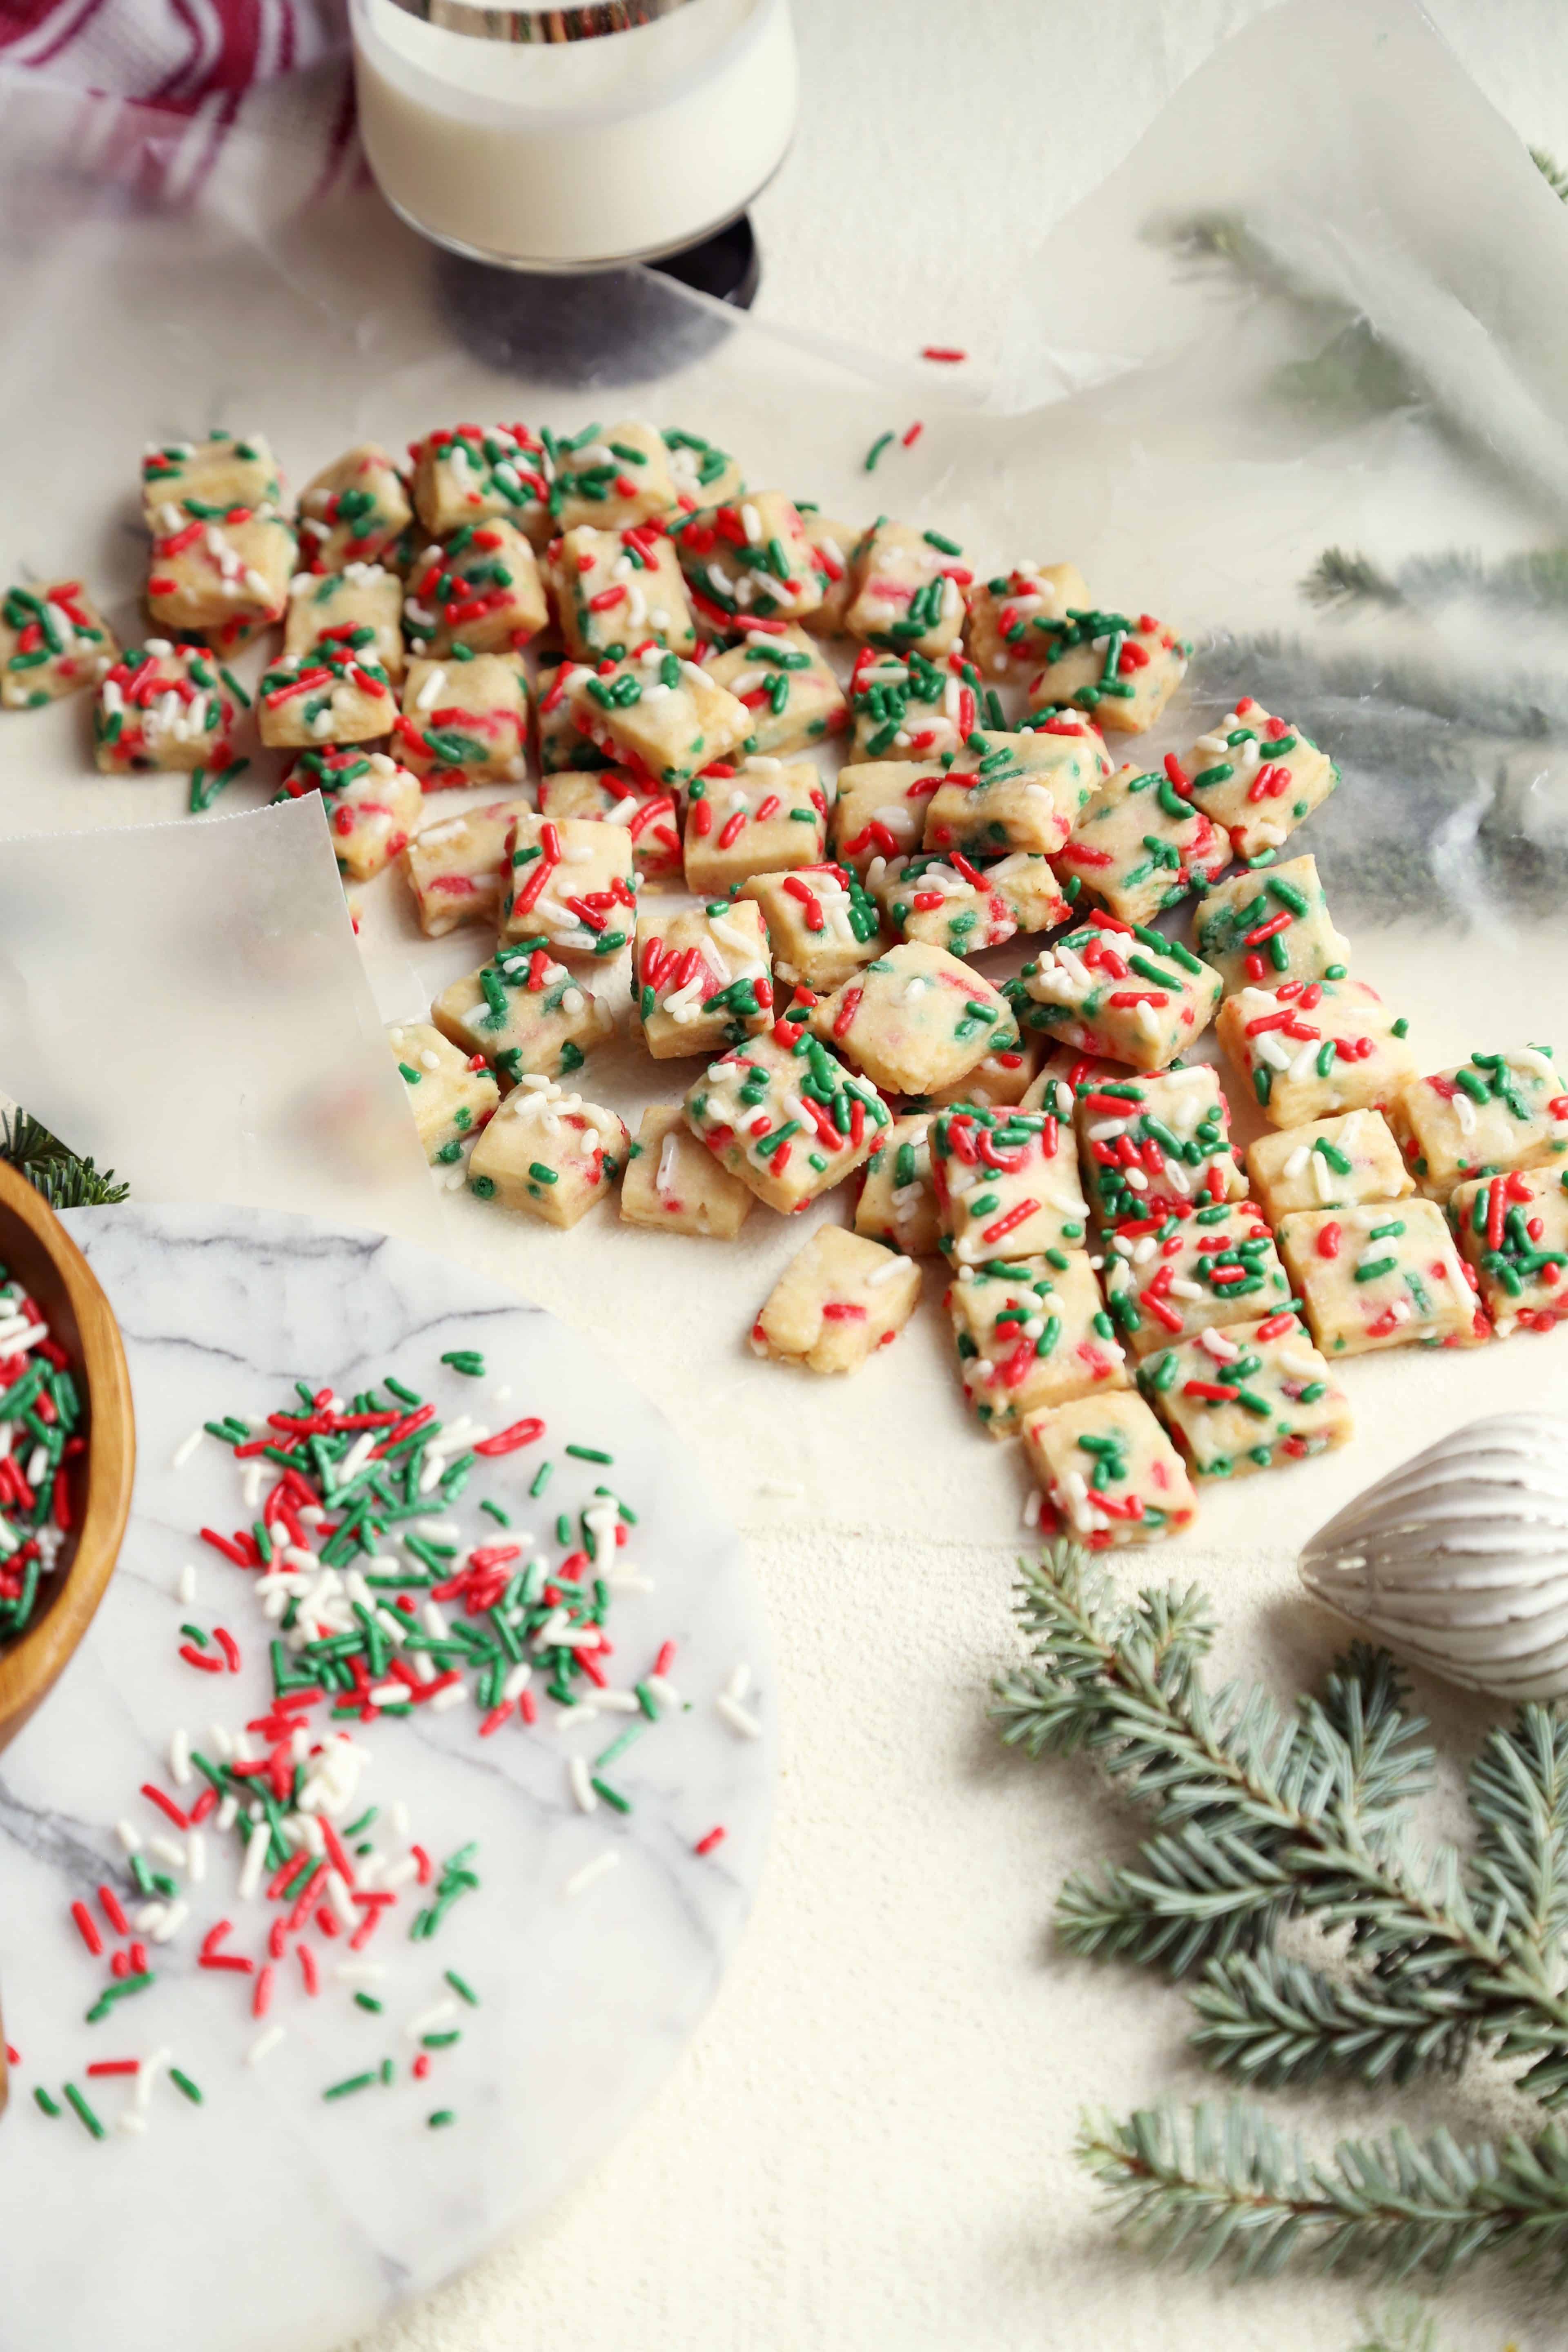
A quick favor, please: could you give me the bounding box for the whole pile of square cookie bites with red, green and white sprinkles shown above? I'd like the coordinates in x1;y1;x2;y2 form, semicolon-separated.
0;421;1568;1548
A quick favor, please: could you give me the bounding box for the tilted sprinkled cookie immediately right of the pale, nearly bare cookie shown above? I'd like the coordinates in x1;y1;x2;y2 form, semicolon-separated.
1006;915;1220;1070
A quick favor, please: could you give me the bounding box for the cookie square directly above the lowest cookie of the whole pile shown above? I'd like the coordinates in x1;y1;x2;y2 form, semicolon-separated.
947;1251;1128;1437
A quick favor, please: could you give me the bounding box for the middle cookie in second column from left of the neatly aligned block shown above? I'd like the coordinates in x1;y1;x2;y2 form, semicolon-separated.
1105;1200;1291;1357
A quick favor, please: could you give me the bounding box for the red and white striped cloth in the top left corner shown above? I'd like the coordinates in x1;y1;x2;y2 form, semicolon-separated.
0;0;360;214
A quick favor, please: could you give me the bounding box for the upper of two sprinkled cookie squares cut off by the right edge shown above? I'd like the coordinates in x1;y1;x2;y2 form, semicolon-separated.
1389;1044;1568;1200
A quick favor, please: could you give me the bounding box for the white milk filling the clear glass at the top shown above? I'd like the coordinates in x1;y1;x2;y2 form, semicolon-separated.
353;0;797;268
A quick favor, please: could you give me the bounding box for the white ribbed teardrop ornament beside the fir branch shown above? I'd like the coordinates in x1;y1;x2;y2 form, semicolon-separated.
1300;1414;1568;1698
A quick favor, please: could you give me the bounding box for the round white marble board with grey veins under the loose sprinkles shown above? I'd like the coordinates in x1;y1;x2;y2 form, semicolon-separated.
0;1207;773;2352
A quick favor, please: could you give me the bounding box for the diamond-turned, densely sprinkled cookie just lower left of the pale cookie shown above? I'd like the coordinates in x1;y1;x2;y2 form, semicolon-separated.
684;1028;891;1216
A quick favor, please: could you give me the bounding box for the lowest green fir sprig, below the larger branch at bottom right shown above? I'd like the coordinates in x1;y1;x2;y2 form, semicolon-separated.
1077;2105;1568;2279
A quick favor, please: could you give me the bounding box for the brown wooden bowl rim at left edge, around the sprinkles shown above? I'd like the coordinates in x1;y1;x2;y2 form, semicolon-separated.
0;1162;136;2110
